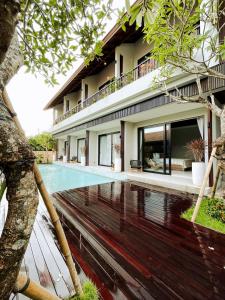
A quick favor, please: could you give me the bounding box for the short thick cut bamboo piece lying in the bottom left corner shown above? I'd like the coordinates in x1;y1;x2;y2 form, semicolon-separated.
14;273;60;300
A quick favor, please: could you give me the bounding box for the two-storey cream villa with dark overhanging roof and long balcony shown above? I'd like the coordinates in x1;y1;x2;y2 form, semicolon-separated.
45;18;225;192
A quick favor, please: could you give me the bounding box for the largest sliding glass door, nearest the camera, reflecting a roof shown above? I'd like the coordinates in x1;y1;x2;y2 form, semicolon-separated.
141;124;171;174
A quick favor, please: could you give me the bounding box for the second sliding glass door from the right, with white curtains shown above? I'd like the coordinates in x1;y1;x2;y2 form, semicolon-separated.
98;132;120;167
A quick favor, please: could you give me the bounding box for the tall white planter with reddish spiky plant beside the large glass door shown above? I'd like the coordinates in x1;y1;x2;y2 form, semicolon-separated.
186;138;206;186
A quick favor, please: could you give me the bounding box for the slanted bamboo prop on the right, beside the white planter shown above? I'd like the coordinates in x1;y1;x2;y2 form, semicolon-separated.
191;147;217;222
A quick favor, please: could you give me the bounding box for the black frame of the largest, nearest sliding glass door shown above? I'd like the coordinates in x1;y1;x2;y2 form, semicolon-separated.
138;122;171;175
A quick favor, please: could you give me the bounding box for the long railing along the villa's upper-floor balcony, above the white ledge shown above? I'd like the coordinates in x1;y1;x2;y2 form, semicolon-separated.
54;59;158;125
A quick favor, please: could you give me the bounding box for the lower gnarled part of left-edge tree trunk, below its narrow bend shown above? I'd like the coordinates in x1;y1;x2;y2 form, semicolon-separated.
0;95;38;300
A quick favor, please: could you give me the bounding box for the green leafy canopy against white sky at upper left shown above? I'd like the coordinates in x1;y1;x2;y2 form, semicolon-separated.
17;0;112;84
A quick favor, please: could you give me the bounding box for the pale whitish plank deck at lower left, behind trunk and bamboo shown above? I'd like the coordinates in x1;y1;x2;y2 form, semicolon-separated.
0;200;79;300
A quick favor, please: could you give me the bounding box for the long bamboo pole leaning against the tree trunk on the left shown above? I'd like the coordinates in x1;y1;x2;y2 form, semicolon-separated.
3;90;83;295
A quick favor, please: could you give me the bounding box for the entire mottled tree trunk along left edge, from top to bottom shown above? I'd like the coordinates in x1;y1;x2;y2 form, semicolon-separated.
0;0;38;300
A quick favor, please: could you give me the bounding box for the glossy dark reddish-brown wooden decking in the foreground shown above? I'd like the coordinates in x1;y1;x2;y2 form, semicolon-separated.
53;182;225;299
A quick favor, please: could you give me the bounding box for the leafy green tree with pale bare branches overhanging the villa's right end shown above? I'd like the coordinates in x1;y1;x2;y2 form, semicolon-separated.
122;0;225;152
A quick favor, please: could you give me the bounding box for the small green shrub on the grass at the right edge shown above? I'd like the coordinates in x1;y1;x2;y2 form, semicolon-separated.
207;198;225;223
